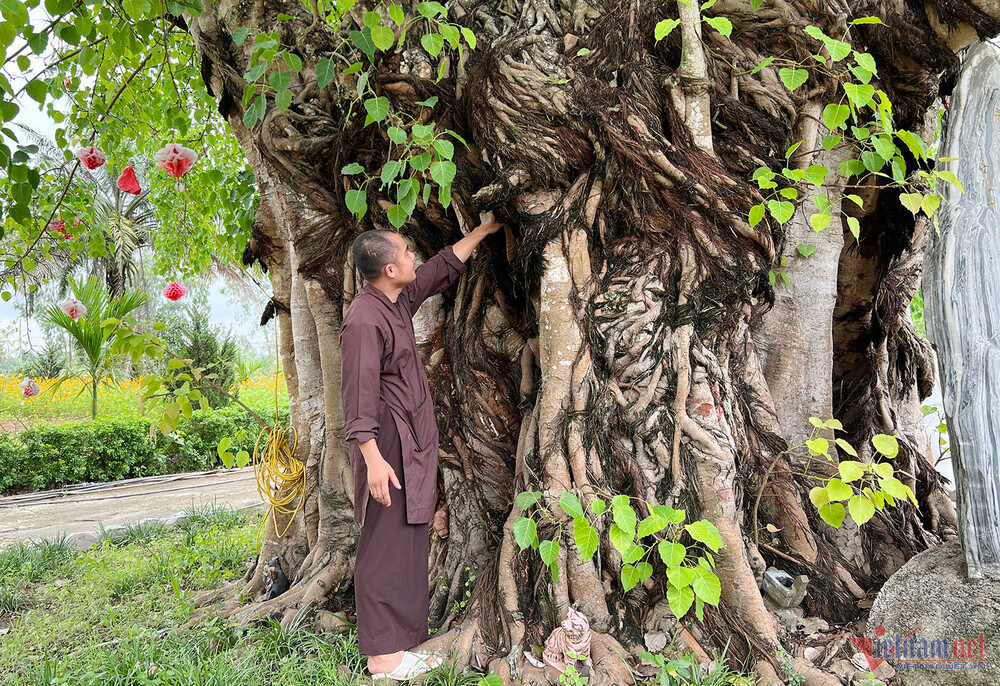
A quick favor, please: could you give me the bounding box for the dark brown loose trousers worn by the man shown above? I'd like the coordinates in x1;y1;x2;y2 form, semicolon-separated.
354;412;430;655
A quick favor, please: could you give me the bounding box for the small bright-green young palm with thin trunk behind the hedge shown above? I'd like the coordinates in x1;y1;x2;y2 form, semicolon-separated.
41;277;148;419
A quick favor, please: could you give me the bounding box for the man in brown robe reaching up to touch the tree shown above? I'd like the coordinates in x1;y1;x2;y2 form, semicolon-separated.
340;214;500;677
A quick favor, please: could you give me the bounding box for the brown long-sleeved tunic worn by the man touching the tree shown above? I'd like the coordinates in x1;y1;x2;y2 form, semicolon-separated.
340;246;466;525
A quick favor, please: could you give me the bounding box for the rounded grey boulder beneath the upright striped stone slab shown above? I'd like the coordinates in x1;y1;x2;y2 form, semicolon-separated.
868;541;1000;686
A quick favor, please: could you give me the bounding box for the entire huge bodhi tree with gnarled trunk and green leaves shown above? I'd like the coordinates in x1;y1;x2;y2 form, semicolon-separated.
0;0;1000;684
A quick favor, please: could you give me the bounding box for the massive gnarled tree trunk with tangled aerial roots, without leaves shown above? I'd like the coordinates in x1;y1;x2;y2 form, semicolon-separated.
186;0;1000;684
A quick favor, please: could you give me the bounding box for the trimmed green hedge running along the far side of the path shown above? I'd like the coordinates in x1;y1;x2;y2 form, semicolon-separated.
0;405;288;493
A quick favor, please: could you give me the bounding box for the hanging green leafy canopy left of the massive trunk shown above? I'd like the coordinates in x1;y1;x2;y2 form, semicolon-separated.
0;0;256;299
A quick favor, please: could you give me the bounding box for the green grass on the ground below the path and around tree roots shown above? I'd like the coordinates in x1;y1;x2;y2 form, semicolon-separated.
0;506;752;686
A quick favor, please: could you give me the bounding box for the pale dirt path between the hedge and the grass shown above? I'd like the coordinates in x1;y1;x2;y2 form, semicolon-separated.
0;467;260;548
